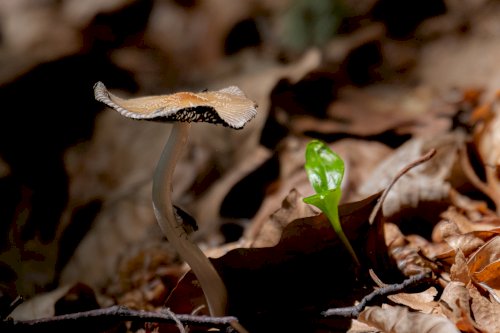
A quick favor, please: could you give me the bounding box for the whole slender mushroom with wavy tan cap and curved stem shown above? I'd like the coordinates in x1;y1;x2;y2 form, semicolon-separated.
94;82;257;316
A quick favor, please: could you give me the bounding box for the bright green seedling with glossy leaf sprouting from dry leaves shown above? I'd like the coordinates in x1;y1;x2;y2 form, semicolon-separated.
304;140;360;266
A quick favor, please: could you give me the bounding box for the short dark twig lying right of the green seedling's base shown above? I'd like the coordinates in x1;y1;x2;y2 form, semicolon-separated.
321;272;430;318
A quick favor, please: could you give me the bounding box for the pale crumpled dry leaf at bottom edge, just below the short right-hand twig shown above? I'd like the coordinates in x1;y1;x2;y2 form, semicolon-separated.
358;306;459;333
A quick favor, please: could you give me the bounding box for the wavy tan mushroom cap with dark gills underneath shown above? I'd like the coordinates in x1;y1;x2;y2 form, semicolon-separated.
94;82;257;129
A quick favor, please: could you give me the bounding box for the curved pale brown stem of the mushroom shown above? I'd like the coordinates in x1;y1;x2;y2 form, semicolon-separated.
153;122;227;316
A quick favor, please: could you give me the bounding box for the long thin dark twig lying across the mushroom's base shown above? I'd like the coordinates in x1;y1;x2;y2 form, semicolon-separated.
0;306;238;332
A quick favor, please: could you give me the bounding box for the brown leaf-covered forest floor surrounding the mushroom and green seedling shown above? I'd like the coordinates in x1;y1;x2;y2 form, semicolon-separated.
0;0;500;333
